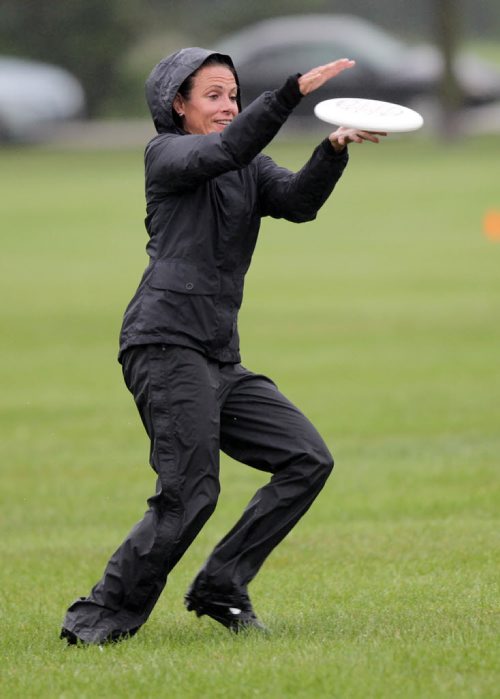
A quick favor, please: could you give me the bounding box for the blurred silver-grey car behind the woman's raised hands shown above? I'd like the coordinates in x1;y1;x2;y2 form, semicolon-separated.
216;14;500;115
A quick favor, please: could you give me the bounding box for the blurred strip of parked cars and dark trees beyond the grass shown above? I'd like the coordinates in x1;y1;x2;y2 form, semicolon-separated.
0;0;500;145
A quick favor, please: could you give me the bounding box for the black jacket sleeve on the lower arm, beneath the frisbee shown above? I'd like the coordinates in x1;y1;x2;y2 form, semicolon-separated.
257;138;349;223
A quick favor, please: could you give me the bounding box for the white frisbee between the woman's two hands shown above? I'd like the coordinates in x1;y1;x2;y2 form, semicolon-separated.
314;97;424;133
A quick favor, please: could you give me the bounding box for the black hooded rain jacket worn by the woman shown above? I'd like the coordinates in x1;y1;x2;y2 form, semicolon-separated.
119;48;348;363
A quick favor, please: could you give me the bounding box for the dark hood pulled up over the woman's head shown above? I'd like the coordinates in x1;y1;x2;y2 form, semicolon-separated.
146;47;241;133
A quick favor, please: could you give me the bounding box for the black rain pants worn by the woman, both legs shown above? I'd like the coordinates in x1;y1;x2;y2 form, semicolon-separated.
63;345;333;643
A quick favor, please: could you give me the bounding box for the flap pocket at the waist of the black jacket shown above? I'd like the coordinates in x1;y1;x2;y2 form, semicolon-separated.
148;258;220;296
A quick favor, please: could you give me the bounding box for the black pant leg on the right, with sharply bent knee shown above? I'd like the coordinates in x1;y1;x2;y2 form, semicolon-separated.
188;367;333;601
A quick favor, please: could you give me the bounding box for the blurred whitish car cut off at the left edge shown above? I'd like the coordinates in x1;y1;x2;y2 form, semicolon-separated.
0;57;85;142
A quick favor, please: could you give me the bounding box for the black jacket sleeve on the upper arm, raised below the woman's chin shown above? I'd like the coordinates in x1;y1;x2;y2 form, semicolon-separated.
145;76;302;194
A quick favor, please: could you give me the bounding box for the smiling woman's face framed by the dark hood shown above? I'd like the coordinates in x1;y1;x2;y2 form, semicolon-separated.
173;65;238;134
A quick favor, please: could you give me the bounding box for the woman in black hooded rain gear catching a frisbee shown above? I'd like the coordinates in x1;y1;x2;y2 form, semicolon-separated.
61;48;384;643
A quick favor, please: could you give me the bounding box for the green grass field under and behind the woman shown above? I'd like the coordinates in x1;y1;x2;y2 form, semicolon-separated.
0;137;500;699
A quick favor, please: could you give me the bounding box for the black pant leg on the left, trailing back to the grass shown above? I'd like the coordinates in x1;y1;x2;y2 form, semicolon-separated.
63;345;220;643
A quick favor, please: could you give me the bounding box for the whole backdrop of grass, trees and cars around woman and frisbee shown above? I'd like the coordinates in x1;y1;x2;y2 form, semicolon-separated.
0;0;500;699
